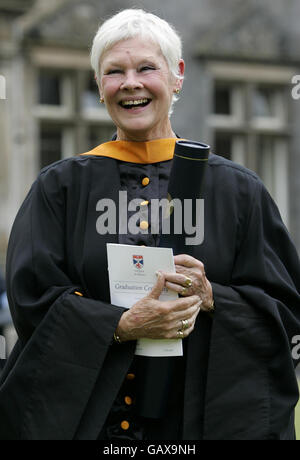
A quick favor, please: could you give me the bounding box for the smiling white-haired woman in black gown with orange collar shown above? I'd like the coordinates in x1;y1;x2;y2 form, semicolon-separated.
0;10;300;440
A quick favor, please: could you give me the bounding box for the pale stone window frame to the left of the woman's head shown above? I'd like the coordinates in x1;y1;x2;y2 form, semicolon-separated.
31;47;115;168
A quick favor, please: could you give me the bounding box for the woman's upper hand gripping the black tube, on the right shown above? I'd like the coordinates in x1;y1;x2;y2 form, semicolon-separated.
164;254;213;311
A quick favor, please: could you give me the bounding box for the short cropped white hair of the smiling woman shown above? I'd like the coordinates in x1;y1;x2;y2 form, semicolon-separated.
90;9;183;113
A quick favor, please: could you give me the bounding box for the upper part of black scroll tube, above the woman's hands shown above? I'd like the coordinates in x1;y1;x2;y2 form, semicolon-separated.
159;140;210;255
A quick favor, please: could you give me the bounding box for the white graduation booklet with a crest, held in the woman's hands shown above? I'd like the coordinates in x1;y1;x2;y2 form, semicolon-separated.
107;243;183;356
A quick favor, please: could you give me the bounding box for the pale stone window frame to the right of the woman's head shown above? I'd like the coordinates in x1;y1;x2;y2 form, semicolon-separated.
206;61;297;227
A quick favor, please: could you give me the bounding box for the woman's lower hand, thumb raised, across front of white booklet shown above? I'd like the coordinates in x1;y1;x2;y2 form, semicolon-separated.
116;272;201;342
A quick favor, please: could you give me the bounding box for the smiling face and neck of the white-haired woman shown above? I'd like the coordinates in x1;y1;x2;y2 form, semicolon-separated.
98;37;184;141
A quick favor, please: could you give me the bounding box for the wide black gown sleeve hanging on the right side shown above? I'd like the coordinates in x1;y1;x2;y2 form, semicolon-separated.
205;181;300;439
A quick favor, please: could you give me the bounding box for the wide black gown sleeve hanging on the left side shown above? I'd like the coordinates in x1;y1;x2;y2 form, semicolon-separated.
0;172;133;439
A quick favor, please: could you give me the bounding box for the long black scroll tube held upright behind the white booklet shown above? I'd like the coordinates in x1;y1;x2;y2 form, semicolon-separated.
135;140;210;424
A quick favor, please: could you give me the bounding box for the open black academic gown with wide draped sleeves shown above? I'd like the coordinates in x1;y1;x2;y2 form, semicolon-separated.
0;150;300;439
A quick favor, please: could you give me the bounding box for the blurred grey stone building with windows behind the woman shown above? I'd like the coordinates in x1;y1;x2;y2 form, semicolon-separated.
0;0;300;438
